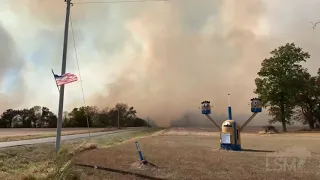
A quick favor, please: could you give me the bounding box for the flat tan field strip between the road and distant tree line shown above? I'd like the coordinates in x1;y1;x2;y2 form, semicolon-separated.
0;128;116;142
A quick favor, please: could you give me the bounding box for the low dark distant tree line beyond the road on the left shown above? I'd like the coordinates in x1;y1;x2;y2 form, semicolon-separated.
0;103;149;128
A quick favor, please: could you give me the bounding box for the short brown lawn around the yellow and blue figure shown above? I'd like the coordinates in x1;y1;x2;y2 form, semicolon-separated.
74;128;320;180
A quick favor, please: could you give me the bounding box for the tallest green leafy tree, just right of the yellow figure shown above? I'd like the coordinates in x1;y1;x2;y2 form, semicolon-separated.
254;43;310;132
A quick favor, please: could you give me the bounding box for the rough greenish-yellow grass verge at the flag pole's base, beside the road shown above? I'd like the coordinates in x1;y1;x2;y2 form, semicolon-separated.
0;129;158;180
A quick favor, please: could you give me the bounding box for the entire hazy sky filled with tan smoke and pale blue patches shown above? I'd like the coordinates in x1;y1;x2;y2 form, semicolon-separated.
0;0;320;126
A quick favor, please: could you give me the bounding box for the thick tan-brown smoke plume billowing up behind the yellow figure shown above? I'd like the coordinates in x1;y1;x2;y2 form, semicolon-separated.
89;0;315;124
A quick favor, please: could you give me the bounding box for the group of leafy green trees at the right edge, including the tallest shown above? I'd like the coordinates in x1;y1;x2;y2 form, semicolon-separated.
254;43;320;132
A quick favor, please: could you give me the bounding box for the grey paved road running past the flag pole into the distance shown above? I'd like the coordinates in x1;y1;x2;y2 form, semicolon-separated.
0;128;143;148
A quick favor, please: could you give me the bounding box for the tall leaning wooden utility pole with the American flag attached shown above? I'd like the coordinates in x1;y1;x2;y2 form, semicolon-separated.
56;0;72;153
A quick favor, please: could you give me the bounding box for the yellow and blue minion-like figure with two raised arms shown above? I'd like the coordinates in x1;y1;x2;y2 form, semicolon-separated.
201;94;262;151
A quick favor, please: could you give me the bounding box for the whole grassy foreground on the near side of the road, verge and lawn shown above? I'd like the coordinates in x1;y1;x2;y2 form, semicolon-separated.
0;128;320;180
